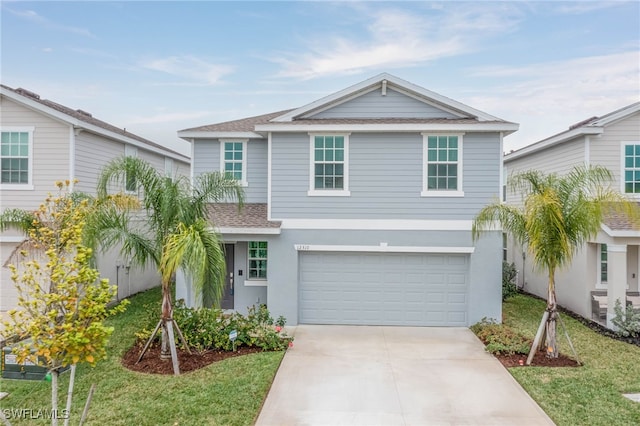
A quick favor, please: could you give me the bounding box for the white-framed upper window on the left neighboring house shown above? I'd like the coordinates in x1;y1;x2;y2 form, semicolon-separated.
0;127;34;190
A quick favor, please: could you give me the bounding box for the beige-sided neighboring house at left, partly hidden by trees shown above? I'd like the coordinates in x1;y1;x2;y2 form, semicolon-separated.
0;85;190;311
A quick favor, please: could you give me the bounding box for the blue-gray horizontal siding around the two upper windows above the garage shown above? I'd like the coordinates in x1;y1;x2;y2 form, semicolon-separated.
271;133;501;220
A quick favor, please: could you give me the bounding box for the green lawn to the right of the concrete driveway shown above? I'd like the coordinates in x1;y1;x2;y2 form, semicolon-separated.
503;295;640;426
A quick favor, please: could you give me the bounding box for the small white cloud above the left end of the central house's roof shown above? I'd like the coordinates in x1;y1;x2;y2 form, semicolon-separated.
138;56;235;86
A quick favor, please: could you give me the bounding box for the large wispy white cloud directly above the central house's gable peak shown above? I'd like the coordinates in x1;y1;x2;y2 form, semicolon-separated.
272;3;521;79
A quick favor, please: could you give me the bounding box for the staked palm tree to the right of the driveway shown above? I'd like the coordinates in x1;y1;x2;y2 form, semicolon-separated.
472;166;640;364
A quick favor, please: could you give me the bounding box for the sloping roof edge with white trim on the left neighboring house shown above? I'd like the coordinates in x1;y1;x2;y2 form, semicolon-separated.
0;84;189;162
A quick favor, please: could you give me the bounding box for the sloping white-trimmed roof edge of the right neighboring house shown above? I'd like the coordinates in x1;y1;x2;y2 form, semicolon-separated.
504;102;640;163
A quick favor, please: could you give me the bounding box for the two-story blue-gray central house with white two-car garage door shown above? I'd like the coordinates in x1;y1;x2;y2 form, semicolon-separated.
176;74;518;326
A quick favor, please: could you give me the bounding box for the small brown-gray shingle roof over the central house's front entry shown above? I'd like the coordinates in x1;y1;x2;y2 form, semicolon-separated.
207;203;281;228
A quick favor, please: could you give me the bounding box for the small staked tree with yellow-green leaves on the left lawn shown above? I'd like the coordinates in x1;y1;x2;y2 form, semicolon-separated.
3;182;128;425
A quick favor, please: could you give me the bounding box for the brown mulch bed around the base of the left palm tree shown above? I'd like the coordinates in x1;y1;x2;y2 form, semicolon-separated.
122;344;262;374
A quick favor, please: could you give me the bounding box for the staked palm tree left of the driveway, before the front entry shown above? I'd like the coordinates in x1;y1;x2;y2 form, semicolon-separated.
94;157;244;374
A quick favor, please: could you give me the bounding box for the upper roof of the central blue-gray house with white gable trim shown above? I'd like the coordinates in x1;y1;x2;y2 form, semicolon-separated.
178;73;518;140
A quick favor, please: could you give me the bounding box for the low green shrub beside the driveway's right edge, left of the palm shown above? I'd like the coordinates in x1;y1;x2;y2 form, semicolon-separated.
469;318;530;355
